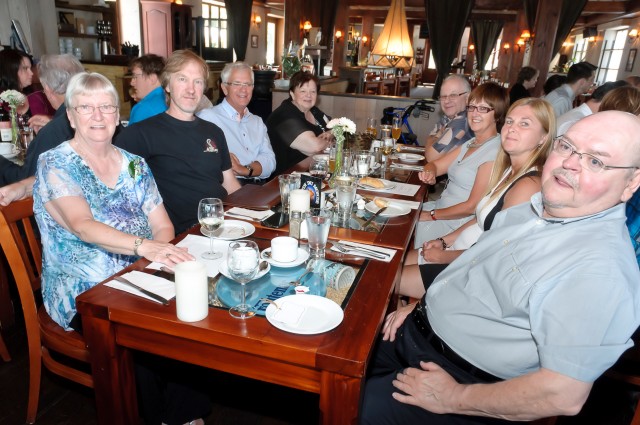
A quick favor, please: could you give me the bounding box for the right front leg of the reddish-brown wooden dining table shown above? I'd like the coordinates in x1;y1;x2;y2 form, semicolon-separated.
320;372;364;425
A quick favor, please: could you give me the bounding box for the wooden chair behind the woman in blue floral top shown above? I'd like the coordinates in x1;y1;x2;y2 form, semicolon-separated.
0;198;93;424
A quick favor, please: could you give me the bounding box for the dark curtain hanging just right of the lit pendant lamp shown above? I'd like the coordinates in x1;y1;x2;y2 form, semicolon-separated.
424;0;474;98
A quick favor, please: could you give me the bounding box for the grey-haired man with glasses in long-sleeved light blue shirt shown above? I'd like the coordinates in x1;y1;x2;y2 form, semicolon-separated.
196;62;276;184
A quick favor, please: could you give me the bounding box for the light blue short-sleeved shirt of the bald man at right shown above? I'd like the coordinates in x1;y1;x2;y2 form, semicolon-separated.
425;193;640;382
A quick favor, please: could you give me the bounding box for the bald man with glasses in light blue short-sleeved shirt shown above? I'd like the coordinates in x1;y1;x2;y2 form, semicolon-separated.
360;111;640;425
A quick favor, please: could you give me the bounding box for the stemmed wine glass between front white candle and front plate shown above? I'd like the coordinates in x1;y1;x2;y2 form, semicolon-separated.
227;240;260;319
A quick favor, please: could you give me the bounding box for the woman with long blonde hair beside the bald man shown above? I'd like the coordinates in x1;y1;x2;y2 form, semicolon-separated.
399;97;556;298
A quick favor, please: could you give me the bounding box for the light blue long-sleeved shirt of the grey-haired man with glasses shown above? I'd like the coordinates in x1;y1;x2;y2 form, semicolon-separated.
196;99;276;178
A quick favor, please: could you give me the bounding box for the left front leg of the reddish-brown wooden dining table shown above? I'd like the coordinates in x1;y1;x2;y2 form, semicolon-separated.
82;314;140;425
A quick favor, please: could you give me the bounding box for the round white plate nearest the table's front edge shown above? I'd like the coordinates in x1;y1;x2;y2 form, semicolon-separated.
265;294;344;335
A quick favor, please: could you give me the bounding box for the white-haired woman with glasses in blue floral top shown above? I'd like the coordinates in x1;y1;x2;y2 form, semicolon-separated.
33;73;193;330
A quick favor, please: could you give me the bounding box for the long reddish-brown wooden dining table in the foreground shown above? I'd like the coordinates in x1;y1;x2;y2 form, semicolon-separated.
76;157;425;425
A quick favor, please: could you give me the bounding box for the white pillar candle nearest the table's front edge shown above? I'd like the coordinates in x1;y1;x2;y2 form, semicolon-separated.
175;261;209;322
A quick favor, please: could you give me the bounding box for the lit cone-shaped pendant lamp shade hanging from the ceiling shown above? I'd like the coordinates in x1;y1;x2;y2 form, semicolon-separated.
371;0;413;68
